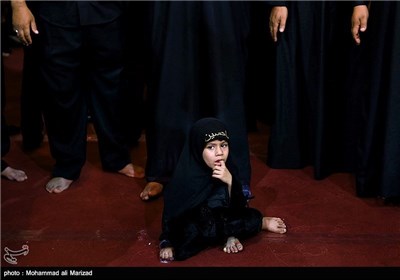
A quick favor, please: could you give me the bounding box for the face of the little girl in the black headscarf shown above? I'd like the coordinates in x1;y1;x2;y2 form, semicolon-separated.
203;140;229;169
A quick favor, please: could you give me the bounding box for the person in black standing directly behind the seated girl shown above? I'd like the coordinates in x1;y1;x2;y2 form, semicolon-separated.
140;1;251;200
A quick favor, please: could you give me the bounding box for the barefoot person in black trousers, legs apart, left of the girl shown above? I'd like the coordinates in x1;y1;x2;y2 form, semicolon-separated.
12;0;144;193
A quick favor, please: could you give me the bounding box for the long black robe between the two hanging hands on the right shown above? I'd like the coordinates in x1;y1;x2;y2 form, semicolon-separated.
267;1;353;179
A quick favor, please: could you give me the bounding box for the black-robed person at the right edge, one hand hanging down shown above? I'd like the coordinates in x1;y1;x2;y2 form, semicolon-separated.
351;1;400;204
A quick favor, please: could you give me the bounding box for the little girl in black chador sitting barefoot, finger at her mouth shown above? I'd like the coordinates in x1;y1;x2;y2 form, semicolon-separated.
160;118;286;262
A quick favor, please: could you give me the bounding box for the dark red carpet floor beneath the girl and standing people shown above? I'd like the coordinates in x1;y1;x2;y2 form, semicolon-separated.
1;47;400;279
